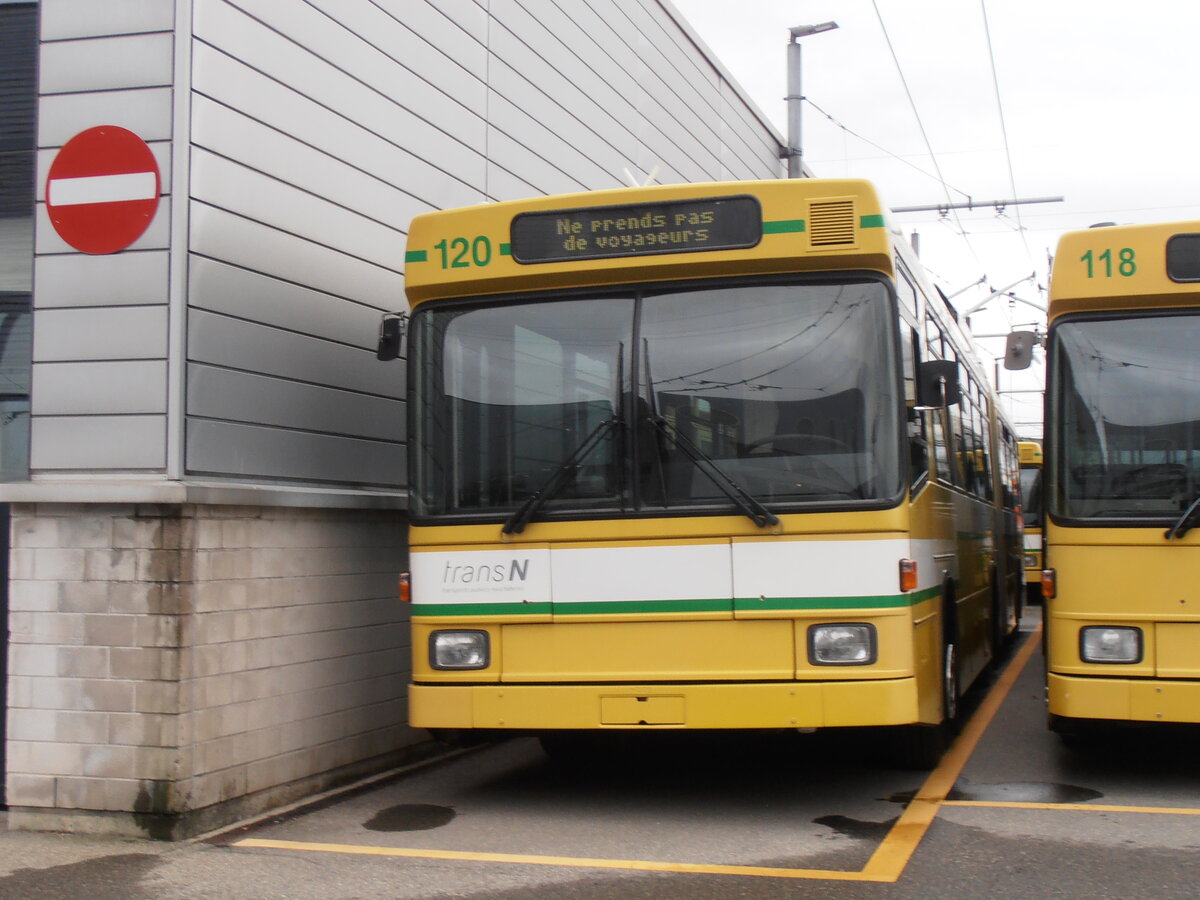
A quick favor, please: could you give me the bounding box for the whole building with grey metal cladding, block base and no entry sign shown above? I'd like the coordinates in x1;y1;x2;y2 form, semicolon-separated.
0;0;782;838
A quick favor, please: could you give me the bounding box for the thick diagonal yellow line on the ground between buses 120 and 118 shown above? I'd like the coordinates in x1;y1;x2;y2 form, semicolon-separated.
862;626;1042;882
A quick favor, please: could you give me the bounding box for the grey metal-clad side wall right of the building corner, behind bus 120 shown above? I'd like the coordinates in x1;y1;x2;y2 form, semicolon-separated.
177;0;780;494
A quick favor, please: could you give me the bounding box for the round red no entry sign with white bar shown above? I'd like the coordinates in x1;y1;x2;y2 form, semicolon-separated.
46;125;162;253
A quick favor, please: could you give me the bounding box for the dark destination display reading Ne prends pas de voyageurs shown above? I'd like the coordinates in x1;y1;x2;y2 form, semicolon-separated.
510;196;762;264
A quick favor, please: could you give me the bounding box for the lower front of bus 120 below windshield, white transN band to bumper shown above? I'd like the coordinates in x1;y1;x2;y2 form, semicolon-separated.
410;518;953;731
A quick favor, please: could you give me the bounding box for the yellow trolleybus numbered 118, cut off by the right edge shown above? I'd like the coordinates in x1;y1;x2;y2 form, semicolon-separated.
1043;222;1200;732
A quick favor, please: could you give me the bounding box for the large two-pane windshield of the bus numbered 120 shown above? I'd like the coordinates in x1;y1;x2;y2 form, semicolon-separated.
410;280;902;518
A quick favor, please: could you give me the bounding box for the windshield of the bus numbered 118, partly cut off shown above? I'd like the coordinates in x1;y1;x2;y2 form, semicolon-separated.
1045;313;1200;523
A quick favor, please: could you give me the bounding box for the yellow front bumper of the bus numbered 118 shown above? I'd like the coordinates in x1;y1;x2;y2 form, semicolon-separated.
1046;672;1200;722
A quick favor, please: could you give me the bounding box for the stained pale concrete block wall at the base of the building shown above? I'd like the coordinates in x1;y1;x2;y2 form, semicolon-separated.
7;504;424;838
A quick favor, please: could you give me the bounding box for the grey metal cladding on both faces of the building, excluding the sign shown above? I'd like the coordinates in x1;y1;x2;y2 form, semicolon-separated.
34;0;780;487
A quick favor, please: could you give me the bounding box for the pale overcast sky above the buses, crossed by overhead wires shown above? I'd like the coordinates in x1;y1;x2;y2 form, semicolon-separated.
671;0;1200;432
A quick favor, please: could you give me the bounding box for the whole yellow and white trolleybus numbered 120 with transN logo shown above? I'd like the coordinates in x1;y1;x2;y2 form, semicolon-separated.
391;179;1021;764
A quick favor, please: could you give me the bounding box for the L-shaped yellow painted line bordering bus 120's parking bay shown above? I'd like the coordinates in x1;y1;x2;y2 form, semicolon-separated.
230;628;1041;882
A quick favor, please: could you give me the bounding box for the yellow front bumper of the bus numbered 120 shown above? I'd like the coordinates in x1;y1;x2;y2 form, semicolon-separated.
408;678;921;731
